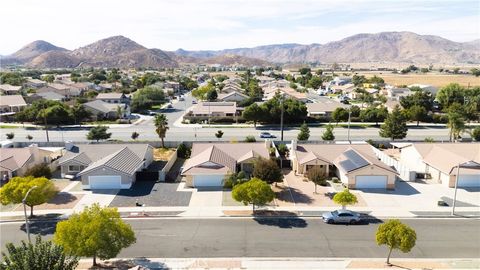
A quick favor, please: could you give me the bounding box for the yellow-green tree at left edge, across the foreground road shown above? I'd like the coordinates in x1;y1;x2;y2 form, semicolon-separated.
0;176;58;216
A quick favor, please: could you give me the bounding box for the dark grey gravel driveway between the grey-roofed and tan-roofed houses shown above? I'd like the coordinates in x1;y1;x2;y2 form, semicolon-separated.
110;181;192;207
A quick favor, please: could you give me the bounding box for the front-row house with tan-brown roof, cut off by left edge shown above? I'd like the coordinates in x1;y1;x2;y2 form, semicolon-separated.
0;144;63;180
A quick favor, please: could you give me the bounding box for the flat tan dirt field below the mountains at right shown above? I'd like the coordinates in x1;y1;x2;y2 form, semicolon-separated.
360;72;480;87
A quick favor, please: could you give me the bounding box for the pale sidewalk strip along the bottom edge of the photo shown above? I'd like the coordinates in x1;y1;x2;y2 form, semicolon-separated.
77;258;480;270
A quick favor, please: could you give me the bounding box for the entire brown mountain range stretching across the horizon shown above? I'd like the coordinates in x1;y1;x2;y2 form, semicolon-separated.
1;32;480;68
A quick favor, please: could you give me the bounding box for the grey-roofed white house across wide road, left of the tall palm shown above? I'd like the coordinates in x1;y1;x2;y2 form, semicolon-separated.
83;100;130;119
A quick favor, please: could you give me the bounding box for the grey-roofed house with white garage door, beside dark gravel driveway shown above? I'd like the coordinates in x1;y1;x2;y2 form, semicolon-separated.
59;142;153;189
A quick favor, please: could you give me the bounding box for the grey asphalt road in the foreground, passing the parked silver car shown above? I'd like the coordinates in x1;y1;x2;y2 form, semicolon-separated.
0;218;480;258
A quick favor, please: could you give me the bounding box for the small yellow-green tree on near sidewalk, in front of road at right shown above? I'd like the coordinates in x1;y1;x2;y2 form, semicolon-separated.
375;219;417;265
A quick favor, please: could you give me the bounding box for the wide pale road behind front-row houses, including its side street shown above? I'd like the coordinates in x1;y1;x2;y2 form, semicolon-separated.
2;94;449;142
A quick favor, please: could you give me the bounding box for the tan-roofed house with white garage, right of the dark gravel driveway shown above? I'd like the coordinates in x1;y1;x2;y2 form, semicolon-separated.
181;140;272;187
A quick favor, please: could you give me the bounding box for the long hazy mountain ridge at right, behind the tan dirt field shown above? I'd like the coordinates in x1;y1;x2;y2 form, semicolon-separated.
176;32;480;64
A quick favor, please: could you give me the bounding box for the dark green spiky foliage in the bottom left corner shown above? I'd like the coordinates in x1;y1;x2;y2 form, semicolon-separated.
0;235;78;270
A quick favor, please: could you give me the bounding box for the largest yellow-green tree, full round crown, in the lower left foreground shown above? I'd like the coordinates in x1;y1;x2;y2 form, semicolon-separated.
53;203;136;266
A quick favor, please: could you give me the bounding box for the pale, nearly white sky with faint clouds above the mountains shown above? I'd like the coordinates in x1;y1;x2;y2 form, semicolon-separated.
0;0;480;55
